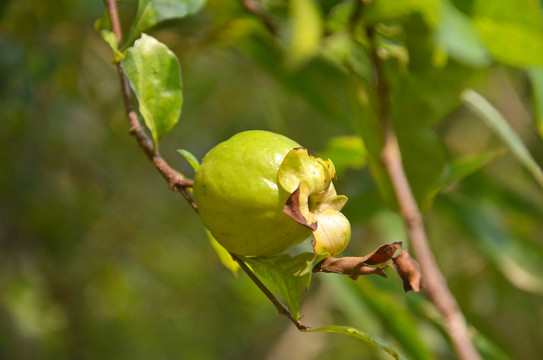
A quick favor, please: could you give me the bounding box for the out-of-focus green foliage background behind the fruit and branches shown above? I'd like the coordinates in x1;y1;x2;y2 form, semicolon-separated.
0;0;543;359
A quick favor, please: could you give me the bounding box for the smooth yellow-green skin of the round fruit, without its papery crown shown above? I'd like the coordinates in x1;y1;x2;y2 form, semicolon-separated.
193;130;311;256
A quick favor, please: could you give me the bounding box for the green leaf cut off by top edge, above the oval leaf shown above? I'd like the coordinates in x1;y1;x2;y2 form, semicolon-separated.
126;0;206;46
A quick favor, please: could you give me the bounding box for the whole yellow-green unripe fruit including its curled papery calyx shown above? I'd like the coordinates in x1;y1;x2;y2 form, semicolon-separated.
193;130;350;256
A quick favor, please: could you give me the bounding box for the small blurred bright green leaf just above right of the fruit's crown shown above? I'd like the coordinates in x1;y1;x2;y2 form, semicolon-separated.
320;136;367;176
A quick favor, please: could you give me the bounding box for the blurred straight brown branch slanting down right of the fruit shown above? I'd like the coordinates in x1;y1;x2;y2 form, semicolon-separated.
367;27;481;360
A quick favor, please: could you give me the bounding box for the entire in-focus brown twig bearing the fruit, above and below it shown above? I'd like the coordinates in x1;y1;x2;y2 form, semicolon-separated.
105;0;308;330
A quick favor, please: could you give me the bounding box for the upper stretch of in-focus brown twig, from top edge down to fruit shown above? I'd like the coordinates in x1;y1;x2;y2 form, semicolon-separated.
105;0;197;210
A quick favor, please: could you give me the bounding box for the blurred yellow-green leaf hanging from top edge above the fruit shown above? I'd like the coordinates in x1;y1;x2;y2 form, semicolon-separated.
288;0;323;67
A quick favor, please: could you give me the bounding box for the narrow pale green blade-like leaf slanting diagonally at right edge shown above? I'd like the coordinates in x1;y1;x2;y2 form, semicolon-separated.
462;89;543;187
